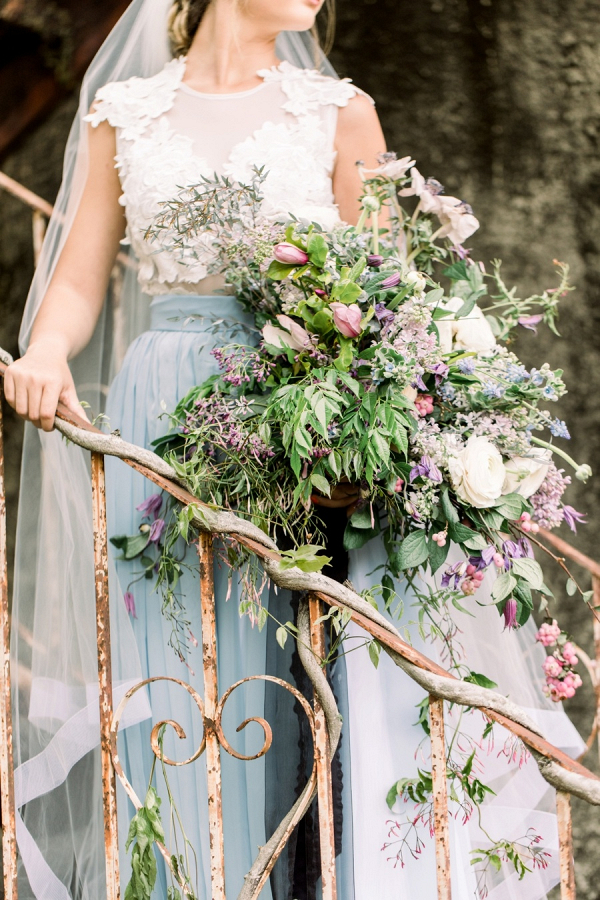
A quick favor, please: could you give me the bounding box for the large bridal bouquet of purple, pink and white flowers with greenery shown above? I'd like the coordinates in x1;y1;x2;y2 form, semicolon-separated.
141;160;591;652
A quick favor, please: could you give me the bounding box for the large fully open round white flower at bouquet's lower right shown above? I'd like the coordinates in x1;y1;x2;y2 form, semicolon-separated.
448;437;506;509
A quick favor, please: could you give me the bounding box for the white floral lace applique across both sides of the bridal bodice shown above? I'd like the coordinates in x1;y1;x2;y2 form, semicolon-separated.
86;57;370;294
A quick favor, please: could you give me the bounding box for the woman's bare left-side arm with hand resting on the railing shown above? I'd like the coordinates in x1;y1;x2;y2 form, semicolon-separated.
4;122;125;431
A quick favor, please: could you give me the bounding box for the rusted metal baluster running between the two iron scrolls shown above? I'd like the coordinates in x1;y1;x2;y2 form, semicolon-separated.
198;534;225;900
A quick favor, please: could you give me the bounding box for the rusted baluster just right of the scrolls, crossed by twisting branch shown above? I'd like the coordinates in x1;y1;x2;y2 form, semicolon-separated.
309;594;337;900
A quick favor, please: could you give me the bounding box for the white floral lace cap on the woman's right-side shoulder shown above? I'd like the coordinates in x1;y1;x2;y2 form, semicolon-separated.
257;61;375;116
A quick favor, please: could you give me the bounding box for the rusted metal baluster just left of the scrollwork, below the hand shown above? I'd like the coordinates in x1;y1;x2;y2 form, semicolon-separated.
92;453;120;900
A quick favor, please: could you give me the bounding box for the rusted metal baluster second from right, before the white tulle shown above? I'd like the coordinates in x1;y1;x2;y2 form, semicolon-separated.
429;695;452;900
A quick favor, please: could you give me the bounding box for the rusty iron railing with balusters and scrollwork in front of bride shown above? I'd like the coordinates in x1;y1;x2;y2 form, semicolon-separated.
0;173;600;900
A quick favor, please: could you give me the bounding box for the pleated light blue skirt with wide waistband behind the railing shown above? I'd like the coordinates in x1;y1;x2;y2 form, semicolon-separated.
106;295;352;900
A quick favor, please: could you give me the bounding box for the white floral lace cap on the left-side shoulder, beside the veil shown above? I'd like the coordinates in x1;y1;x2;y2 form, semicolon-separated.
85;57;185;138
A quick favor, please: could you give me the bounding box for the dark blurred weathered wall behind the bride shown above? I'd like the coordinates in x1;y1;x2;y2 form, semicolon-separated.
0;0;600;900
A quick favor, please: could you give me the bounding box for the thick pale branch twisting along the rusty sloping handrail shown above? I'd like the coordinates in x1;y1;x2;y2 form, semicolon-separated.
0;346;600;808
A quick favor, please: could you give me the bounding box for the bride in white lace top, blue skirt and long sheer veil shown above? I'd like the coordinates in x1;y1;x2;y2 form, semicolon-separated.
5;0;580;900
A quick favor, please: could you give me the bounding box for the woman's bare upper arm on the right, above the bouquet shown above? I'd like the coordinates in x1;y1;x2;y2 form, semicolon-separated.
333;94;385;225
